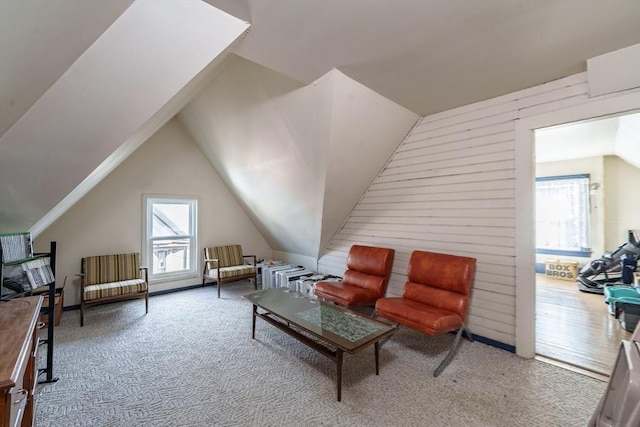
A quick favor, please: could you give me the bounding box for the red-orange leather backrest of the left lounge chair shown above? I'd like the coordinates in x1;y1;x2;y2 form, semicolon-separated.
342;245;395;297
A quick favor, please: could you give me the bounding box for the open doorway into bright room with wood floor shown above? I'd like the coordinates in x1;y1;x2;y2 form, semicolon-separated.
534;113;640;376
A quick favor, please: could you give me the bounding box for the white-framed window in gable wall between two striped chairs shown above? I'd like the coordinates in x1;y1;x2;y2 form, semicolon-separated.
144;196;197;279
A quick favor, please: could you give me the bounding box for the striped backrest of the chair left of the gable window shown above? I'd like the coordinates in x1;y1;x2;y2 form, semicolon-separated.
82;252;140;285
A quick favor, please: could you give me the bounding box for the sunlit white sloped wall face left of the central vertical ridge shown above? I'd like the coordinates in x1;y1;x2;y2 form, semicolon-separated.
179;57;331;255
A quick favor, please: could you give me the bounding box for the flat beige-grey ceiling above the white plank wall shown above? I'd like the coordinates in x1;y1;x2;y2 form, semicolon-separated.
206;0;640;115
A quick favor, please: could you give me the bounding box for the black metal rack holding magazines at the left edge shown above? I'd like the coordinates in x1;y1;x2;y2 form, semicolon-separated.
0;232;58;384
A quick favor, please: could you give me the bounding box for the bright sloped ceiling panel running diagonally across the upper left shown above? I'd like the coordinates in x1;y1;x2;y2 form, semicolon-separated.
0;0;248;231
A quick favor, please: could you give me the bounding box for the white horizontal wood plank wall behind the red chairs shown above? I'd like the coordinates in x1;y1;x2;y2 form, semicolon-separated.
318;73;588;345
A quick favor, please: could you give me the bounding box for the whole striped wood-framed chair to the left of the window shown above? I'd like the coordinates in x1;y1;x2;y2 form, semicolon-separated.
80;253;149;326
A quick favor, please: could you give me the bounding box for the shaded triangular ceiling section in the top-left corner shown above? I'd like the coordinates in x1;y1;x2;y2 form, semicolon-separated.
0;0;133;136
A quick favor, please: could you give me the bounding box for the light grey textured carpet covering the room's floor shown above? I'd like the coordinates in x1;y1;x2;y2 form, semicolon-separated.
36;283;606;427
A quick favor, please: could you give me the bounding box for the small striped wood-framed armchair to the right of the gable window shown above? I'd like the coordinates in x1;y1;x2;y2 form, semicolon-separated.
202;245;258;298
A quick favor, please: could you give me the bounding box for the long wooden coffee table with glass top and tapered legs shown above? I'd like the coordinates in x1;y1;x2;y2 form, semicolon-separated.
244;288;398;401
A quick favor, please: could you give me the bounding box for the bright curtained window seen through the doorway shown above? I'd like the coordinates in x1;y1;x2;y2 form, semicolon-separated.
536;175;590;256
